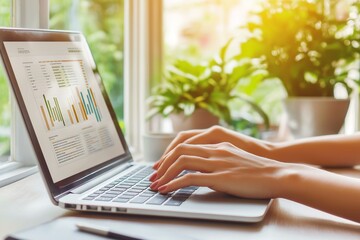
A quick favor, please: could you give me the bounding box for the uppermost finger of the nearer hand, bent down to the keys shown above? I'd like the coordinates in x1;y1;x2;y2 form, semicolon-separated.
156;144;211;179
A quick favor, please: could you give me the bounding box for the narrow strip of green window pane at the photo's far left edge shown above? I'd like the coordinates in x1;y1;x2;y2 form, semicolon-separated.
0;1;11;156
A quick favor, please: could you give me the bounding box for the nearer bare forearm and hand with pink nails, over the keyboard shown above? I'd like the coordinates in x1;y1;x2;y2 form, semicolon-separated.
150;143;360;223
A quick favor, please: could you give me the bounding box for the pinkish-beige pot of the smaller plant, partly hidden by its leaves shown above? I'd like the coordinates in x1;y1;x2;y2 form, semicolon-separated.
170;108;219;132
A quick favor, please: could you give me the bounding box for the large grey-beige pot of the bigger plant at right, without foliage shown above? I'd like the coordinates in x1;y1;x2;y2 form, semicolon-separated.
284;97;350;138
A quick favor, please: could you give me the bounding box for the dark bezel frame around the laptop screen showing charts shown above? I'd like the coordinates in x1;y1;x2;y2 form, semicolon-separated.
0;28;132;204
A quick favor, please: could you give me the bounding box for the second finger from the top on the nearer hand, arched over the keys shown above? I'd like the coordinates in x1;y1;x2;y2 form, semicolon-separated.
153;156;219;190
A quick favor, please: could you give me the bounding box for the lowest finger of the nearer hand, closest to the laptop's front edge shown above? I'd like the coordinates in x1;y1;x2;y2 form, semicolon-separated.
158;173;216;193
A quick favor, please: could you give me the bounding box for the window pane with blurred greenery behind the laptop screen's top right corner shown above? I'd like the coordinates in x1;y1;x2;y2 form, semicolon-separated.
50;0;124;126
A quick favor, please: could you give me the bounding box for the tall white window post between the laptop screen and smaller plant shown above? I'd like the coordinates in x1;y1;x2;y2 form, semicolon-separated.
124;0;163;156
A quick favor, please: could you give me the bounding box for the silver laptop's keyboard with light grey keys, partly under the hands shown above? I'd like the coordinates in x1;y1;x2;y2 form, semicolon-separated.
84;166;198;206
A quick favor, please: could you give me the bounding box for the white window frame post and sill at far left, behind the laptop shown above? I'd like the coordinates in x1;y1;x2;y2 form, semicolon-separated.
0;0;49;187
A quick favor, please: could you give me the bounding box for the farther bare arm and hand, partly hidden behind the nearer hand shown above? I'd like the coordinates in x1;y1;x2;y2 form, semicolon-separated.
155;127;360;168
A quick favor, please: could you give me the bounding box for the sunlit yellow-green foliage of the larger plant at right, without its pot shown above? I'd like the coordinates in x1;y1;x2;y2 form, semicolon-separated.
238;0;360;96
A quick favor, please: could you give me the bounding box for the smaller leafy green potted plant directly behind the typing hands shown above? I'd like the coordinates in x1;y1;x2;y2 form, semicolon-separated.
148;40;269;132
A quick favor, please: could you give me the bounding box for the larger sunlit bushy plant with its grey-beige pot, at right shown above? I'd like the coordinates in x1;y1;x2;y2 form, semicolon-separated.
238;1;360;137
